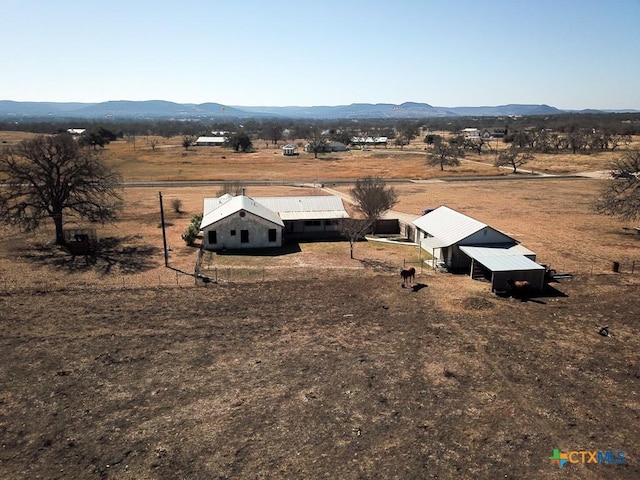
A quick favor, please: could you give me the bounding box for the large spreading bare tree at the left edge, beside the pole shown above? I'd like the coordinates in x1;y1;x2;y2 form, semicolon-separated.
0;134;122;245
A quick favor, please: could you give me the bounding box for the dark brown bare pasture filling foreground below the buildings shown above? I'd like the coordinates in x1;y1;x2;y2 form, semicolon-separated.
0;273;640;479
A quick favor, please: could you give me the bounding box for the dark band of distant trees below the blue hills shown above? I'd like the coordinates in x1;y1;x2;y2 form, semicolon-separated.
0;113;640;146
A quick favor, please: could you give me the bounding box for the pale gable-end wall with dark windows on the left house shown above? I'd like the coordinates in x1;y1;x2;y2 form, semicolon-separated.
202;212;282;250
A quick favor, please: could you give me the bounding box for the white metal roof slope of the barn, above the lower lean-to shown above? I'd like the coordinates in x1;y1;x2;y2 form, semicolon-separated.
413;206;488;248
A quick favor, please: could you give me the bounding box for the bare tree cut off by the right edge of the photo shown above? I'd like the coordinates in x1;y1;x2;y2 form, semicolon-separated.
595;150;640;221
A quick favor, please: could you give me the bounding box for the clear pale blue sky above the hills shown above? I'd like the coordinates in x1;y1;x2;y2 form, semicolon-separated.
0;0;640;109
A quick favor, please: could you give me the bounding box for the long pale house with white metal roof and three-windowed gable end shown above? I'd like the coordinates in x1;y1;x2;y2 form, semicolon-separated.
200;194;349;250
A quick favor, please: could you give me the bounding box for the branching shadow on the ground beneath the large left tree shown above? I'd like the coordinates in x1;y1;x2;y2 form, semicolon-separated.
23;235;162;275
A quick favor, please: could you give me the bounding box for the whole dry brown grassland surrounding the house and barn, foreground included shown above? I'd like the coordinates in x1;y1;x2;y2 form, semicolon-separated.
0;132;640;479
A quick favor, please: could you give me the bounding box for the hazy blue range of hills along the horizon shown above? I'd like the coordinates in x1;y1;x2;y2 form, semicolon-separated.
0;100;637;120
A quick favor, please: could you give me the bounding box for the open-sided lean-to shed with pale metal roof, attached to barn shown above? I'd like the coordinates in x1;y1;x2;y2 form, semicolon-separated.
460;246;545;291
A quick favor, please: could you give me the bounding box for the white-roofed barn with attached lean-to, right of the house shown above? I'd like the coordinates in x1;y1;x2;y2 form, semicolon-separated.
413;206;545;290
